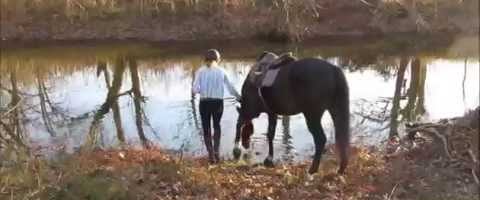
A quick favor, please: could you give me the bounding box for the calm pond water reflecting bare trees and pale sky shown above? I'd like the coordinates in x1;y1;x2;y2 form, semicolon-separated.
0;37;479;161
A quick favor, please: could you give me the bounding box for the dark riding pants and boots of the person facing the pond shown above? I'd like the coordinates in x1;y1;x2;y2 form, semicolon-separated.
200;99;223;162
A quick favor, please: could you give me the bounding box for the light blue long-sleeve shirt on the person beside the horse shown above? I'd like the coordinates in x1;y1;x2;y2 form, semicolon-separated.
192;65;240;99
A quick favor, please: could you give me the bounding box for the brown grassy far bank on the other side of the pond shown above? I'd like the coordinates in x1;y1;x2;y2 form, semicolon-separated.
0;0;478;41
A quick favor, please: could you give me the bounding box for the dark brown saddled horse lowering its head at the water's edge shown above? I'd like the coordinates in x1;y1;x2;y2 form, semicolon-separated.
234;52;350;174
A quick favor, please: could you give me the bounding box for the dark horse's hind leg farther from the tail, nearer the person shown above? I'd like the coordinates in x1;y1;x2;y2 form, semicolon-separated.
304;111;327;174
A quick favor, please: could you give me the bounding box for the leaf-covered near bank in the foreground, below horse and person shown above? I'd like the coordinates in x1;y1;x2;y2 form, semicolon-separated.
0;111;479;200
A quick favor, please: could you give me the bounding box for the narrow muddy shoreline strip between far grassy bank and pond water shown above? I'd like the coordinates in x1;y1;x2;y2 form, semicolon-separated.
0;32;470;48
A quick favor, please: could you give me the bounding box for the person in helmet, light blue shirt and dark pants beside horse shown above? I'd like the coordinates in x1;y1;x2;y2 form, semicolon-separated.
192;49;240;163
